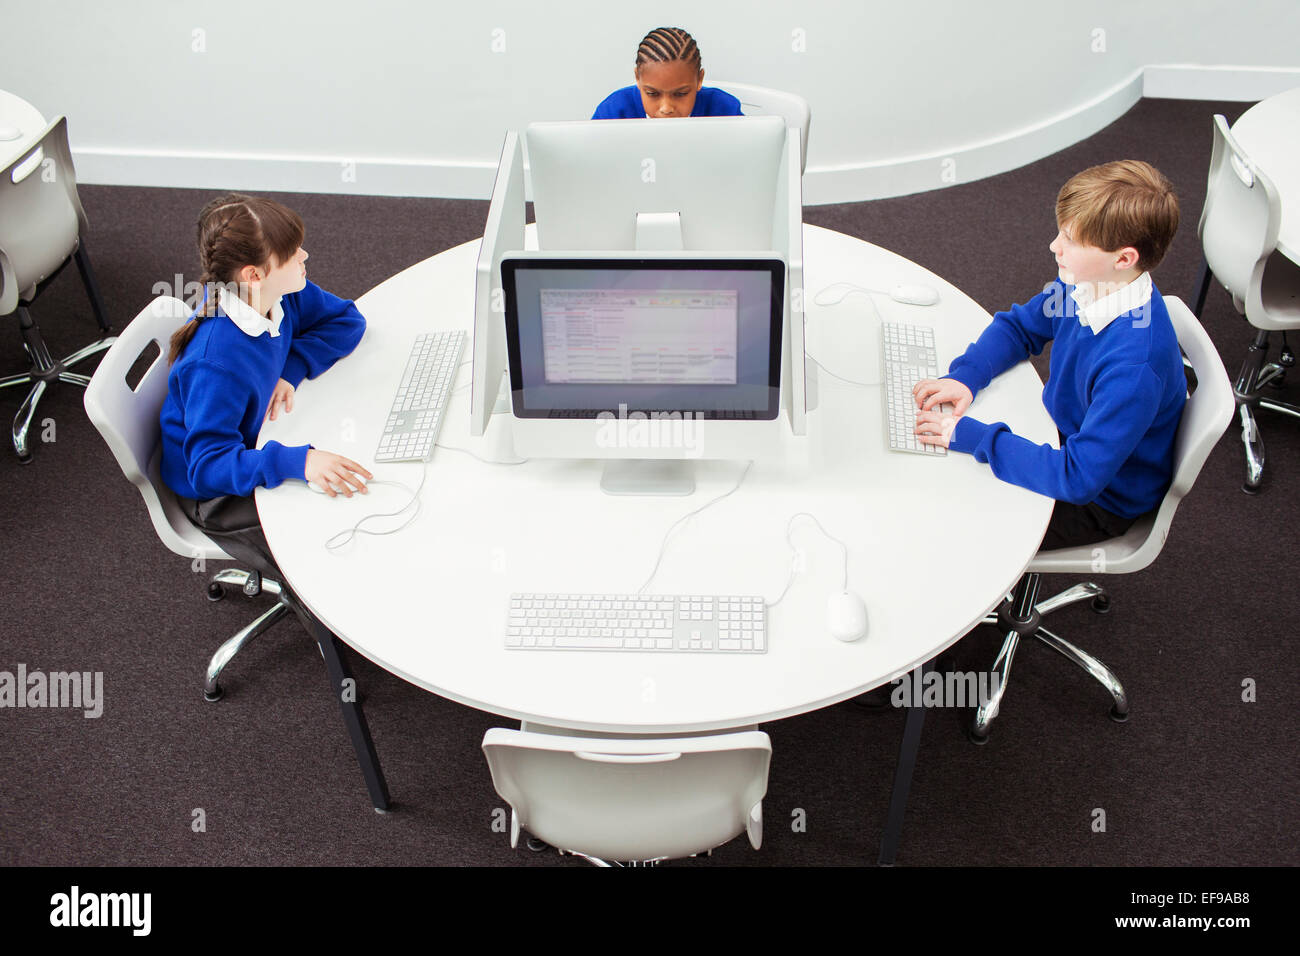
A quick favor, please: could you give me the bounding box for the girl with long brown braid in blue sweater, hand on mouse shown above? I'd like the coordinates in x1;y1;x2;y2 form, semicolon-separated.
160;194;371;576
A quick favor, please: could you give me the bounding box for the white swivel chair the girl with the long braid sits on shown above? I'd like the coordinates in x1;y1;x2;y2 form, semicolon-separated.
86;295;290;701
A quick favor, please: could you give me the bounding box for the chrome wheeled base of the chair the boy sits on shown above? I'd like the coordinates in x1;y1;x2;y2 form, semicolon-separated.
967;571;1128;744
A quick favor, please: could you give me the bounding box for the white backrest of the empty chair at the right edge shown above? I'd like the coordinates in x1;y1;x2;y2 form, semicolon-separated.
1196;114;1282;310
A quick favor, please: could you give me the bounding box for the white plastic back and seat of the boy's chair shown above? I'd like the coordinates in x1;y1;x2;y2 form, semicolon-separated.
1030;295;1236;574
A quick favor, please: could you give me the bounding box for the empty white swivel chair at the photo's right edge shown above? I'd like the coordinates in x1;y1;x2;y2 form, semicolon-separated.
1196;116;1300;494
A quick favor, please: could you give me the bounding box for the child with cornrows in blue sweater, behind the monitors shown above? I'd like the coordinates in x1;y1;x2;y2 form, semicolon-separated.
592;26;741;120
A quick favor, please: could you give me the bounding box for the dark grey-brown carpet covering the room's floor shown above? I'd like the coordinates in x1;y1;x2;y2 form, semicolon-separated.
0;100;1300;865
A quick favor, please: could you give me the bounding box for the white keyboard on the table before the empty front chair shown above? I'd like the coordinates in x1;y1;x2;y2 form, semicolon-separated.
506;594;767;654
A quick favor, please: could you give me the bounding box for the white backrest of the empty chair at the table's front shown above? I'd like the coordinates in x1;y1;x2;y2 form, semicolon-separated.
482;728;772;861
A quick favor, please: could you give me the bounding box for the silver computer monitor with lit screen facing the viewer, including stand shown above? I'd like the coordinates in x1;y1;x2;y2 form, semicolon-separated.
501;251;785;494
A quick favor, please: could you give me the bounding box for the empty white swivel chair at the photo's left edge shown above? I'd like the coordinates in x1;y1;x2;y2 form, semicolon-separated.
0;116;113;463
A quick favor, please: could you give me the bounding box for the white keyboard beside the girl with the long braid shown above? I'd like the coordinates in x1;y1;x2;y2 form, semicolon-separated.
374;329;465;462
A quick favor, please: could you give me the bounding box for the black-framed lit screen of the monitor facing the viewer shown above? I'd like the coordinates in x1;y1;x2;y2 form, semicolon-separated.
502;259;785;420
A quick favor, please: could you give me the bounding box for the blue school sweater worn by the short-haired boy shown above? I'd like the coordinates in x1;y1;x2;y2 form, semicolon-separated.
948;280;1187;518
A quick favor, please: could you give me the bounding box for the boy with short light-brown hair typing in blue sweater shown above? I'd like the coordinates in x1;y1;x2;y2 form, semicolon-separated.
913;160;1187;550
